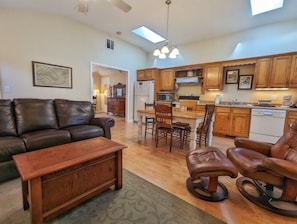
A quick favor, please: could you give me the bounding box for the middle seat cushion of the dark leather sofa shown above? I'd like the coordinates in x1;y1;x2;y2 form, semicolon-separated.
21;129;71;151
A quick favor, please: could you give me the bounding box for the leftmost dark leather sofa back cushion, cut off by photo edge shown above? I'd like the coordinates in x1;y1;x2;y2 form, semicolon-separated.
0;99;17;137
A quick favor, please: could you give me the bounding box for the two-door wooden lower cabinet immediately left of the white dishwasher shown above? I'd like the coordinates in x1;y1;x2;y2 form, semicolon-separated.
213;107;251;138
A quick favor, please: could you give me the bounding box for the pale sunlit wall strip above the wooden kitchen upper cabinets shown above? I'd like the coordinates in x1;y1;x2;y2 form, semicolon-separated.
148;20;297;68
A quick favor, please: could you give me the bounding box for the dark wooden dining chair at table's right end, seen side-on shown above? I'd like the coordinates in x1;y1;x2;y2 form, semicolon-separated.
196;104;215;148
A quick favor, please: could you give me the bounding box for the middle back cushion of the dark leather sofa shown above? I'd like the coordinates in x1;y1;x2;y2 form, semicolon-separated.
14;99;58;135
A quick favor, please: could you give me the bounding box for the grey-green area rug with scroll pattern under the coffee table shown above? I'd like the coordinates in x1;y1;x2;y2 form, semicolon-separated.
1;170;223;224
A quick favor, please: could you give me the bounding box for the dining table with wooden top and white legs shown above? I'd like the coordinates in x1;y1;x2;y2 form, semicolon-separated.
137;109;214;151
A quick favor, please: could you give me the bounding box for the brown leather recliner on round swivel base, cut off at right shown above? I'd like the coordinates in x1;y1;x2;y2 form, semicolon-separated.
227;120;297;217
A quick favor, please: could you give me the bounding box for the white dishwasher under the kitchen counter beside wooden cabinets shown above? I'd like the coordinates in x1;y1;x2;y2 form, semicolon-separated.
249;108;286;143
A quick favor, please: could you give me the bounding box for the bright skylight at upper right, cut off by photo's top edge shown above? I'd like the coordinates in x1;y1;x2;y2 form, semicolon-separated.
250;0;284;16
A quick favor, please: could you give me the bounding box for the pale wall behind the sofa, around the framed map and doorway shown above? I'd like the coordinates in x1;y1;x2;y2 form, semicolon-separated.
0;8;147;120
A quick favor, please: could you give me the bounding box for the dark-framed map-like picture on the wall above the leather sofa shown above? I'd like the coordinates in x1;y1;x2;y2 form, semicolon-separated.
32;61;72;89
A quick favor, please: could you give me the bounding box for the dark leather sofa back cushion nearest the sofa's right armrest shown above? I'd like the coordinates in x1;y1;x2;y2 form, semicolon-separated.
55;99;94;128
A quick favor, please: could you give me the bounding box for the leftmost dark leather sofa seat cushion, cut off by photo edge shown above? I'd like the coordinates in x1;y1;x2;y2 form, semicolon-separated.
0;136;26;162
